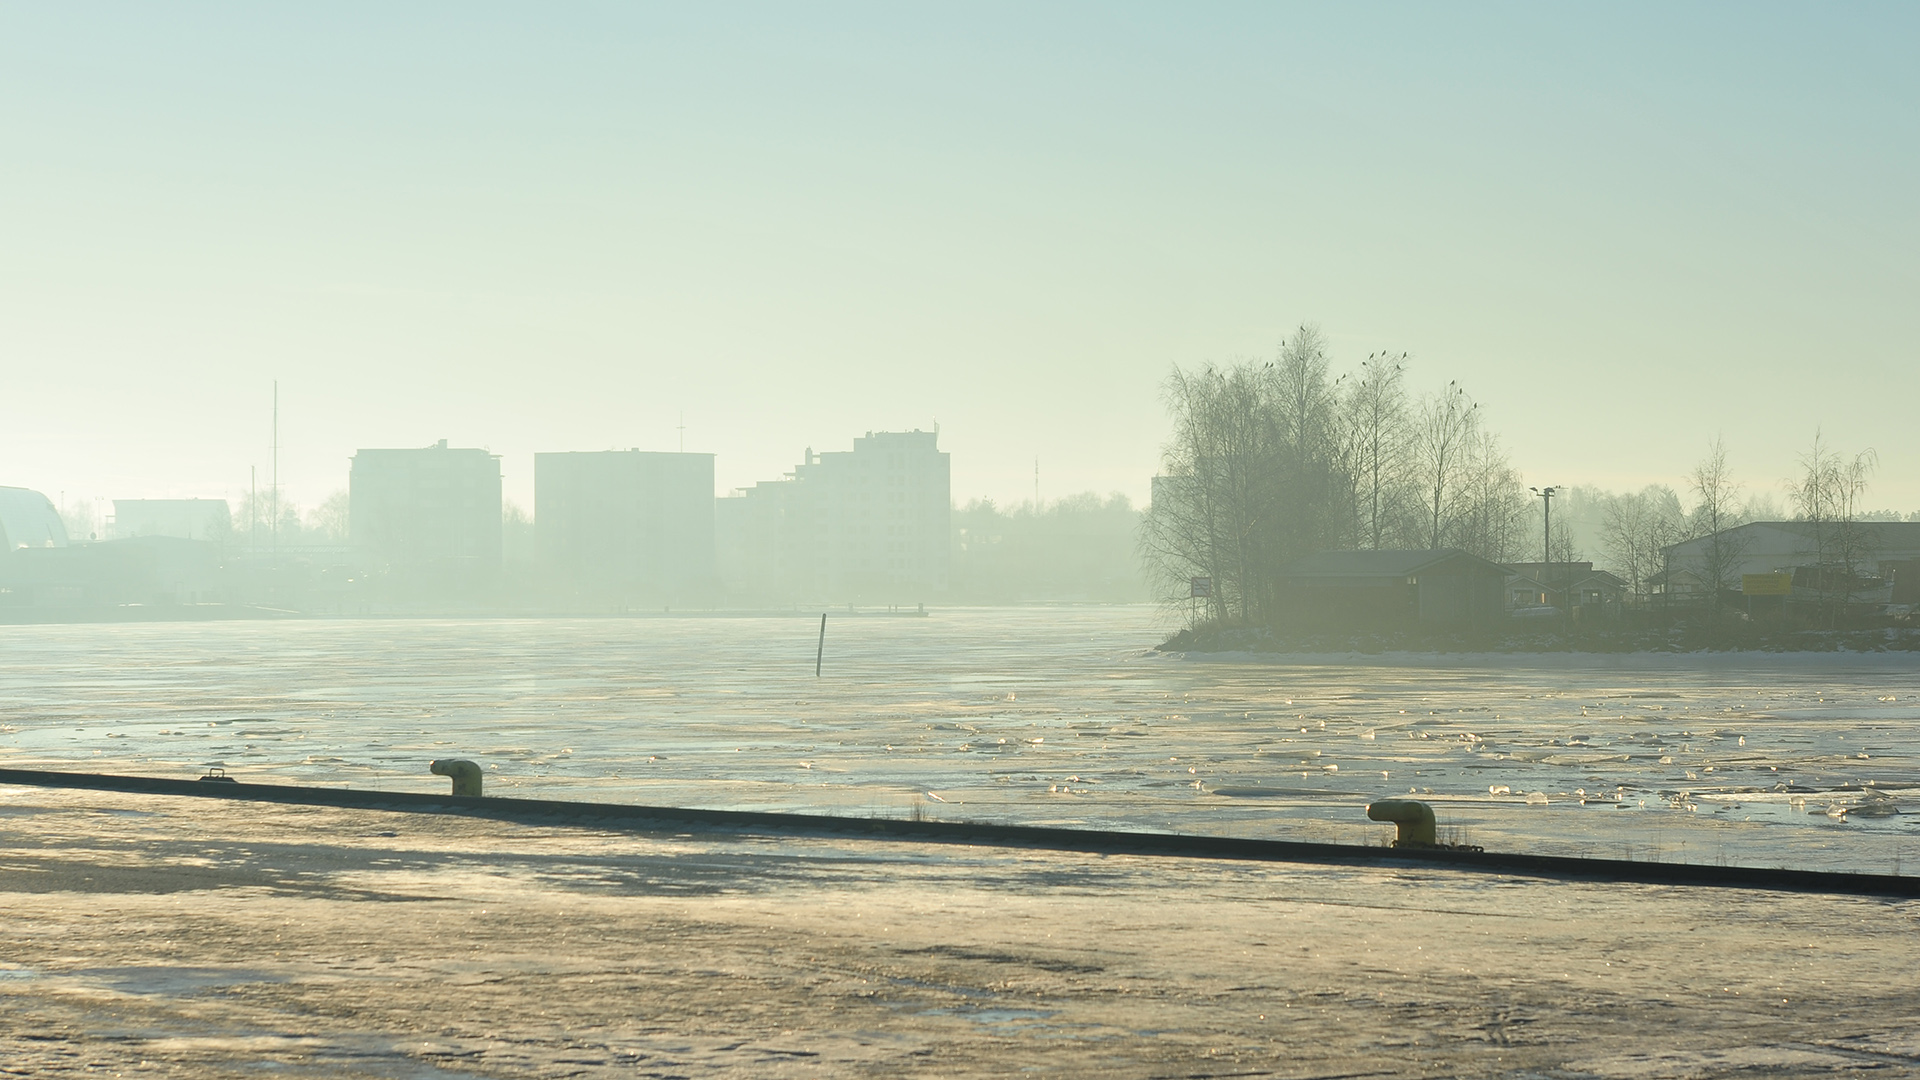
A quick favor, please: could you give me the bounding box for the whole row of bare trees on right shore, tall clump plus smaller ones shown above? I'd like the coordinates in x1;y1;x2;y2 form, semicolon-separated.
1139;315;1920;625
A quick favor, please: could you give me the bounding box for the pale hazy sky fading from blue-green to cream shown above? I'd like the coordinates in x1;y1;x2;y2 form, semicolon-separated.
0;0;1920;509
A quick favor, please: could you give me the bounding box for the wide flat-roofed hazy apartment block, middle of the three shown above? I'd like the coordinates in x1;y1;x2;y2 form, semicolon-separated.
534;450;716;603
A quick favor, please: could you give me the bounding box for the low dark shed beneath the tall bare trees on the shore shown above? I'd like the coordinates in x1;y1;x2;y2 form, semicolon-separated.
1277;548;1509;628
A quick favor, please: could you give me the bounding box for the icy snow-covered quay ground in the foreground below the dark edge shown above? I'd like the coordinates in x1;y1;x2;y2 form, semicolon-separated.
0;788;1920;1080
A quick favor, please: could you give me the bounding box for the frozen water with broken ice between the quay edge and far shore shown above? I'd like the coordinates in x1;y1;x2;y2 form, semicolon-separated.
0;607;1920;872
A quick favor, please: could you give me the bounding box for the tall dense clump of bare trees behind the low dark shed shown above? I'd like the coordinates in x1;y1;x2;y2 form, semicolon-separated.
1140;327;1538;623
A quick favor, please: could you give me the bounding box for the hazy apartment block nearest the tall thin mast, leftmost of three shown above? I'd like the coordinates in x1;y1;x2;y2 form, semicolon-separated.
348;438;501;575
